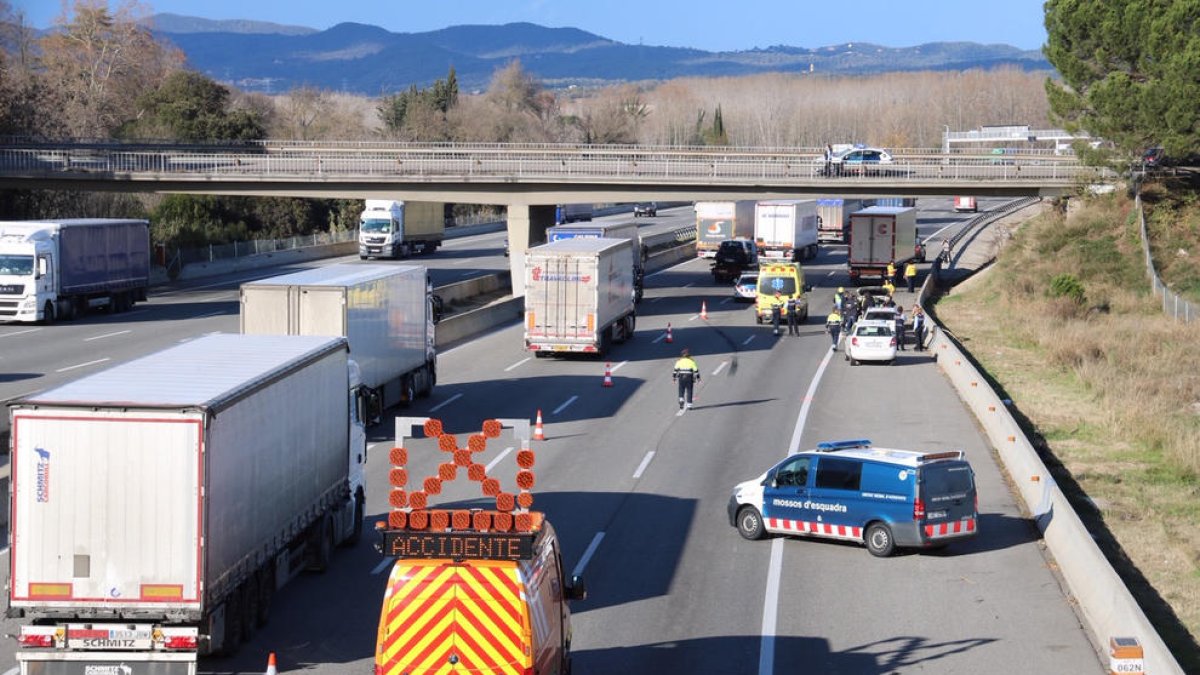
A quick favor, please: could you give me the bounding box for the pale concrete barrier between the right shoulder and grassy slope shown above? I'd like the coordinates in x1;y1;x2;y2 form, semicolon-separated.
920;268;1183;675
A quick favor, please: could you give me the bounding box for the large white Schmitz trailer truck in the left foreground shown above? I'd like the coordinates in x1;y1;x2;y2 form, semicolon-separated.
7;334;366;675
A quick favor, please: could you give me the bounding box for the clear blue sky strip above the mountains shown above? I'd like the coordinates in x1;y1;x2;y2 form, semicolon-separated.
18;0;1045;50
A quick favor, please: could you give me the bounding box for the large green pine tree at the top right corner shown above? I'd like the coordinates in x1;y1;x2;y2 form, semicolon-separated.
1044;0;1200;156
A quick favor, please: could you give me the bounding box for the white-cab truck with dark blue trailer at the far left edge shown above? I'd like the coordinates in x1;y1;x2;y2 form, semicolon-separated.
0;219;150;323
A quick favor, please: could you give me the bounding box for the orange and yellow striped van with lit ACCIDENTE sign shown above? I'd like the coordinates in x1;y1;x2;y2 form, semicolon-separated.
374;418;587;675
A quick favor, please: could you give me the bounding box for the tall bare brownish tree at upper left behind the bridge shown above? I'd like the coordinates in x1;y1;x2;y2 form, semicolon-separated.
40;0;184;137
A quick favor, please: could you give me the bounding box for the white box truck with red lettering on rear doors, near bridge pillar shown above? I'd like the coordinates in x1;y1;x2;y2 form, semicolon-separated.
524;239;635;357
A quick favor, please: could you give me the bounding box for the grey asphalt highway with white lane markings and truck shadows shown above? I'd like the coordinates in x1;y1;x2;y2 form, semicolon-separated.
0;199;1103;675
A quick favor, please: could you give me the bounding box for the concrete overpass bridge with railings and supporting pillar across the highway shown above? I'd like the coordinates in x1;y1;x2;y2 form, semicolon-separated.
0;141;1115;294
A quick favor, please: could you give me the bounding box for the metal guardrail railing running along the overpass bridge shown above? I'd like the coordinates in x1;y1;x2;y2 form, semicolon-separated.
0;144;1111;186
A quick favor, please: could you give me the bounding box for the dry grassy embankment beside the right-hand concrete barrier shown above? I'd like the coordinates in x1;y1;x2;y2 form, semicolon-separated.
935;193;1200;673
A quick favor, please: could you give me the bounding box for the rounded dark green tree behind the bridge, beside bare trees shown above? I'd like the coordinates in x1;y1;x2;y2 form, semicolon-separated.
121;71;266;141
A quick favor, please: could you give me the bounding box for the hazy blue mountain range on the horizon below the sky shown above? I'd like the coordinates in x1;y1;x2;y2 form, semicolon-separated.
151;14;1051;96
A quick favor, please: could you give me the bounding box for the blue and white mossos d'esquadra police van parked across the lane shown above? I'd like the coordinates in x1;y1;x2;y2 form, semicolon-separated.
728;440;979;557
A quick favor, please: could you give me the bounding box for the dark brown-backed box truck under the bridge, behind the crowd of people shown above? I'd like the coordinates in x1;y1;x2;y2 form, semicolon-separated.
847;201;925;285
